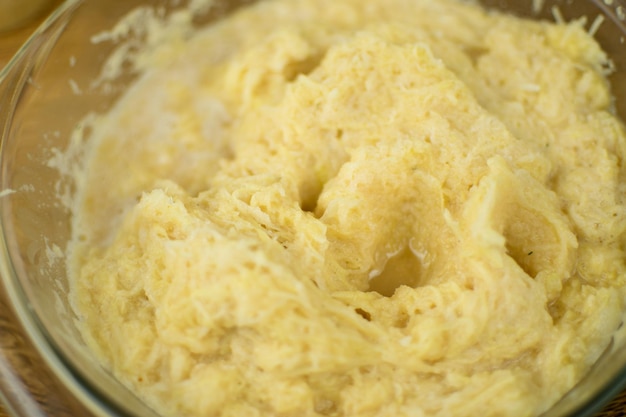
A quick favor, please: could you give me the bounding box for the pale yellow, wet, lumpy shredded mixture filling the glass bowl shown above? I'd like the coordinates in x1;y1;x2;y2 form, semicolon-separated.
70;0;626;417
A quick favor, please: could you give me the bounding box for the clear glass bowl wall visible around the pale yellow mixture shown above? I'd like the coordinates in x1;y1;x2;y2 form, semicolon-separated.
0;0;626;417
